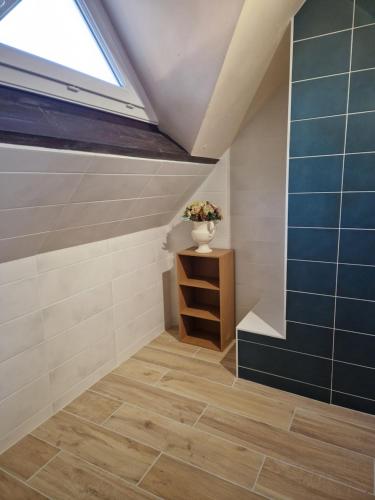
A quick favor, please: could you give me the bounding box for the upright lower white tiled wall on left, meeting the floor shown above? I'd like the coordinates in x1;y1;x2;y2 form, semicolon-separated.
0;226;173;451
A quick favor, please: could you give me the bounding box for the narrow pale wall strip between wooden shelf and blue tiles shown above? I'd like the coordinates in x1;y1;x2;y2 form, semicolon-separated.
230;82;288;334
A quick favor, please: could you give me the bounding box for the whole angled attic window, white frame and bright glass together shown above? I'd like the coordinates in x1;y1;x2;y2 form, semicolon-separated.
0;0;157;123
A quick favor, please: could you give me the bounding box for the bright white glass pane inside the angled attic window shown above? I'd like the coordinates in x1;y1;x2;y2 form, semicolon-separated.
0;0;119;86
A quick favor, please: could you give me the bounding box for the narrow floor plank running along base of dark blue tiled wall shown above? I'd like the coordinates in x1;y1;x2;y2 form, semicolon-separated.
234;379;375;430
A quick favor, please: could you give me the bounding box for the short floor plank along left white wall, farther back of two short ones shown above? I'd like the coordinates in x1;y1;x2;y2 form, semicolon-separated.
65;391;121;424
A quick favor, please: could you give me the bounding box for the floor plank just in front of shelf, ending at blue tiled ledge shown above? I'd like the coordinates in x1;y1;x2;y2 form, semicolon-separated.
134;347;234;385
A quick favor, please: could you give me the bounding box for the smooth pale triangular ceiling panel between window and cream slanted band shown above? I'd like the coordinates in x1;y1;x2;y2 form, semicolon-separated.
103;0;244;158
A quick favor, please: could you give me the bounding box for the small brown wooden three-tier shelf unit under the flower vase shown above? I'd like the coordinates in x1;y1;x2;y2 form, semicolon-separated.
176;248;235;351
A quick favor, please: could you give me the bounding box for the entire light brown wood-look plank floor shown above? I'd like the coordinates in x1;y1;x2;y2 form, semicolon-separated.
0;333;375;500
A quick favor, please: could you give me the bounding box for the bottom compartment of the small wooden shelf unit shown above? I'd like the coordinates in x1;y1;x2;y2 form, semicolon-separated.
180;315;221;351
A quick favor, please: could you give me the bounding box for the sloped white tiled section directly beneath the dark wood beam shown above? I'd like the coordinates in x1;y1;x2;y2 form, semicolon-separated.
0;144;214;262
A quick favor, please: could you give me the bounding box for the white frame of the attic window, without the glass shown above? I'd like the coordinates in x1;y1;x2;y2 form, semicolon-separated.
0;0;157;123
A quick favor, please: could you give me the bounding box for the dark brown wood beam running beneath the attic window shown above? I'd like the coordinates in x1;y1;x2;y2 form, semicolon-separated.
0;85;218;164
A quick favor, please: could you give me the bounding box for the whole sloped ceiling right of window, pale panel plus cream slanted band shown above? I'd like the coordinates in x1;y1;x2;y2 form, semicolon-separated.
103;0;303;158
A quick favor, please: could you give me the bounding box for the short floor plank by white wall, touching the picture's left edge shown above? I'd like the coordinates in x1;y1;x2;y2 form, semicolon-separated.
0;435;59;479
